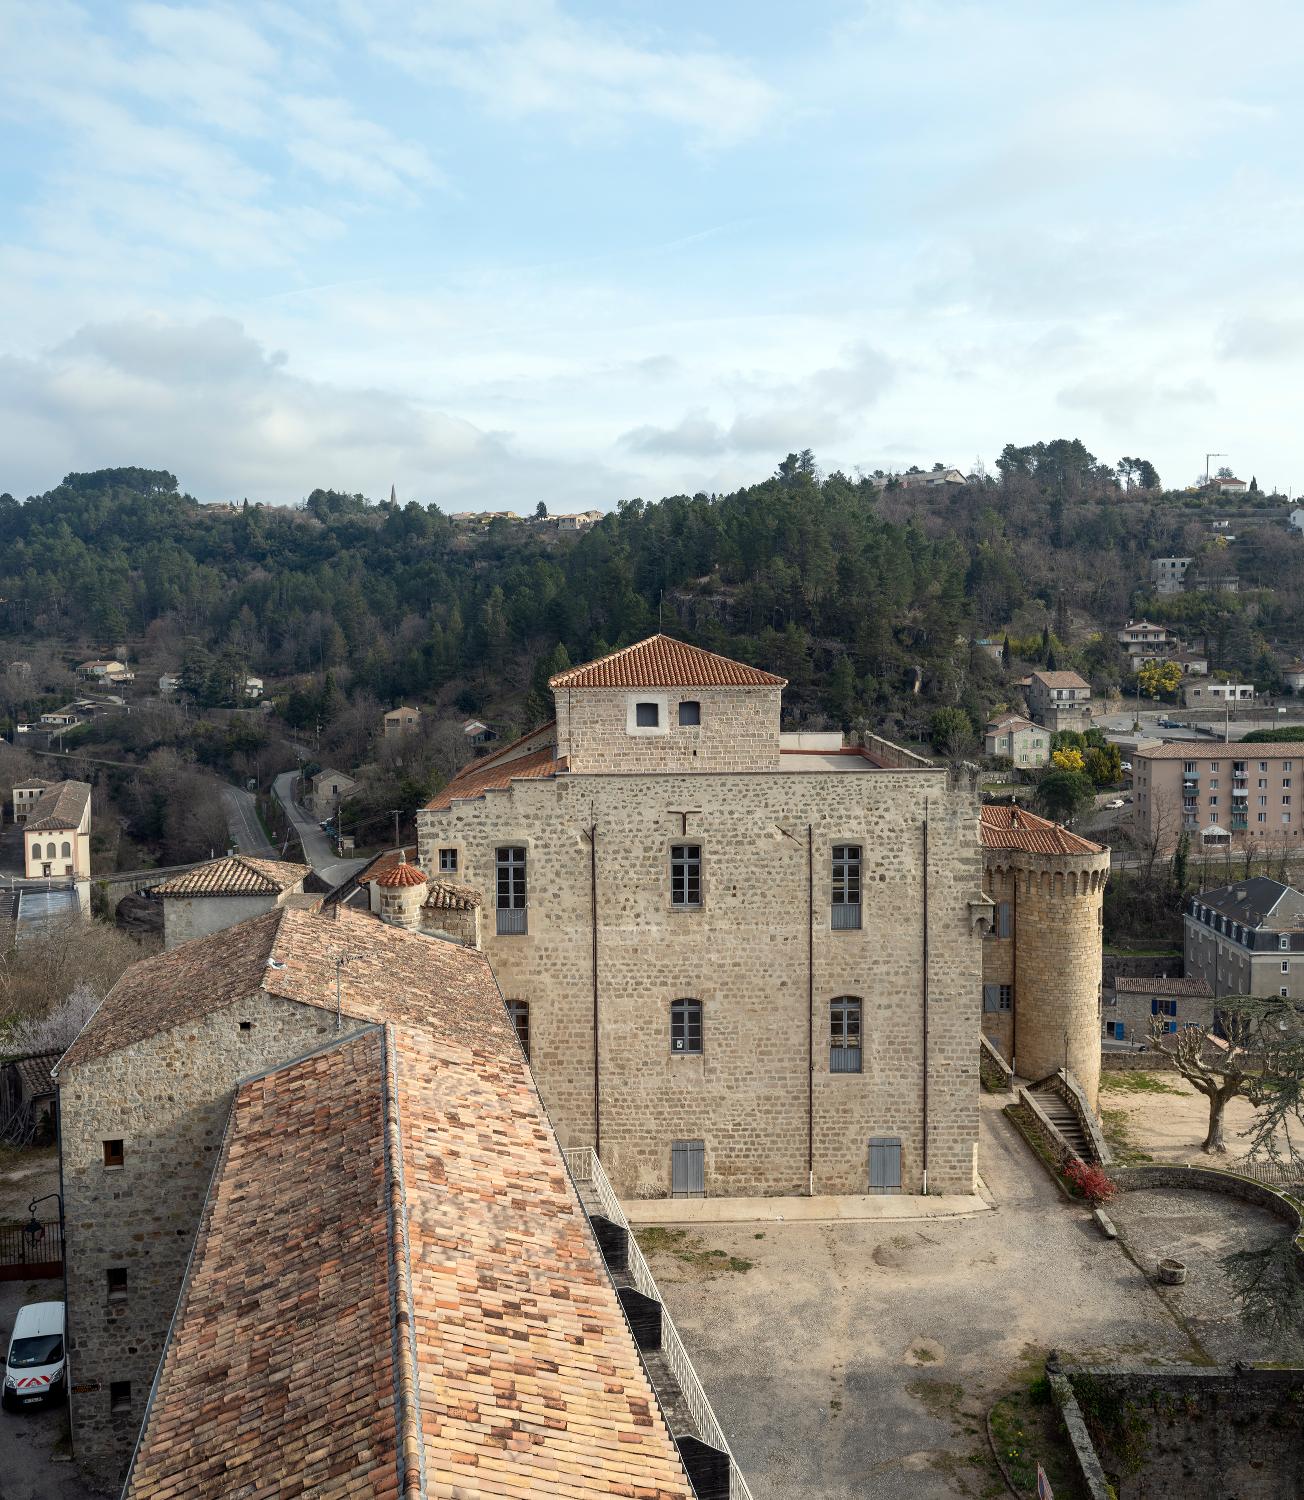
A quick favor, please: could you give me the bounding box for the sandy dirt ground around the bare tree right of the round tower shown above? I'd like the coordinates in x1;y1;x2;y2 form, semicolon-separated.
1100;1071;1290;1166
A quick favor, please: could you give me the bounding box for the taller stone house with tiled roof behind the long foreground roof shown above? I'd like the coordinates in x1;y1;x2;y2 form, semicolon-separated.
56;906;501;1493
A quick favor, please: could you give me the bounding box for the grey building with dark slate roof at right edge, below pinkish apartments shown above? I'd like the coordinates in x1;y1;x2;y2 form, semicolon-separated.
1182;875;1304;1001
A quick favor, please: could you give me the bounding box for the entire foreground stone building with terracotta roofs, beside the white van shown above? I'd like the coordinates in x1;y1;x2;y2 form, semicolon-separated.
57;906;702;1500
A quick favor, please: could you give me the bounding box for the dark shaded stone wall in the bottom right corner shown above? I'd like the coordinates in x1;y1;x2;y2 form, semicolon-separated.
1047;1367;1304;1500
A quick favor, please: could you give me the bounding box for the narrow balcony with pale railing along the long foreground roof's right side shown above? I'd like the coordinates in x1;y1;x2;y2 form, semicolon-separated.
564;1146;752;1500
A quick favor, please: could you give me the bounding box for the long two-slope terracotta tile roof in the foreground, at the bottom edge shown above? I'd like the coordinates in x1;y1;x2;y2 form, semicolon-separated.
125;1004;692;1500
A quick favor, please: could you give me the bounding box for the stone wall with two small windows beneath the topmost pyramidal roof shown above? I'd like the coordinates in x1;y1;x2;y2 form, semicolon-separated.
554;687;780;774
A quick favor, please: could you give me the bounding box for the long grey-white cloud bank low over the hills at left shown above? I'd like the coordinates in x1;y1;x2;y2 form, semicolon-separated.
0;318;621;510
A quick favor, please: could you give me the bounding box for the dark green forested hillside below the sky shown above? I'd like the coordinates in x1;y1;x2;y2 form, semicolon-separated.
0;441;1304;738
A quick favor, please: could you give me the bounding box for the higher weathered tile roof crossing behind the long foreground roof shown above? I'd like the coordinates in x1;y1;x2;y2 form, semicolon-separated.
59;905;503;1076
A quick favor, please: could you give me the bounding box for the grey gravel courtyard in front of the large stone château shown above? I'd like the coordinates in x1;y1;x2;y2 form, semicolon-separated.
650;1097;1290;1500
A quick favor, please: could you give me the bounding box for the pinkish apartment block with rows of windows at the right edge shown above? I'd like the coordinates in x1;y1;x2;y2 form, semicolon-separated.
1131;741;1304;851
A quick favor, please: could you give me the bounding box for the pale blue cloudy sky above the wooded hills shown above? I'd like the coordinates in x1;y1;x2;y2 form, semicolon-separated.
0;0;1304;512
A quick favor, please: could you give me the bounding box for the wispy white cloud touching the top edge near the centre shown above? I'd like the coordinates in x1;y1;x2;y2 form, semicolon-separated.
345;0;777;147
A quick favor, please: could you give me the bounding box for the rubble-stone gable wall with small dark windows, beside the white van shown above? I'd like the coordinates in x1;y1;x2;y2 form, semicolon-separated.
59;992;353;1482
